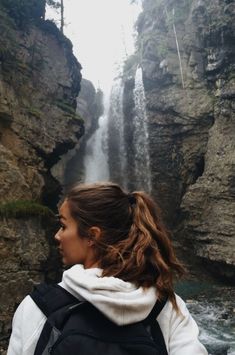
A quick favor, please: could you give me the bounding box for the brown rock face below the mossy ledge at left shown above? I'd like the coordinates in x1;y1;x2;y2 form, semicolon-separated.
0;218;49;346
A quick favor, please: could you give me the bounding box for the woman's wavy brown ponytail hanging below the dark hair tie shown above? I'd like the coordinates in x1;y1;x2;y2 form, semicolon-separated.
129;192;184;308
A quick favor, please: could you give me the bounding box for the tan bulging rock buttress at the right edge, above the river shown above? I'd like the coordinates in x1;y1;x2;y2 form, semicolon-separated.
181;102;235;281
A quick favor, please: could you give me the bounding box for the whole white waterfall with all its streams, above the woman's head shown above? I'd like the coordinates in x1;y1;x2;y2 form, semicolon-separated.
84;68;152;193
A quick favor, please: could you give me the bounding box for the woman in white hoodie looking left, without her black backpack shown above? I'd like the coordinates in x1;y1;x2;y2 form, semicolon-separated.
8;183;207;355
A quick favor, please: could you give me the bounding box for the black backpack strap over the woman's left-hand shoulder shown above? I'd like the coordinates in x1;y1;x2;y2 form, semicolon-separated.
30;283;81;317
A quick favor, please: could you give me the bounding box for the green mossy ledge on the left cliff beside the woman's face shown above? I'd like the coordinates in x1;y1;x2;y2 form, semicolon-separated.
0;200;55;218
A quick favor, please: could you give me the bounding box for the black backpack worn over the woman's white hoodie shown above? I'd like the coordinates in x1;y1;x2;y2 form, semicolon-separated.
30;284;167;355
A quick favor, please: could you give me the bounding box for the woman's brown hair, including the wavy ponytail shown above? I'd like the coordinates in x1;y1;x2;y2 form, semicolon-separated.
66;183;184;309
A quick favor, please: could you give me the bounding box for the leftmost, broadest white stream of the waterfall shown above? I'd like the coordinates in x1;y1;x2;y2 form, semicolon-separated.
84;99;109;183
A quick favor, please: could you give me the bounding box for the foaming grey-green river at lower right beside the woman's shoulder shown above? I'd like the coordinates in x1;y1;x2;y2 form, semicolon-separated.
176;281;235;355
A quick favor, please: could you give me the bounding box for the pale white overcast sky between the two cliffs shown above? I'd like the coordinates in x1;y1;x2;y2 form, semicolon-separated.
47;0;141;91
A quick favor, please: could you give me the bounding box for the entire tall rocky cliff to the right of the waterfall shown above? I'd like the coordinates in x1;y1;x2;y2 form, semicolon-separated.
124;0;235;280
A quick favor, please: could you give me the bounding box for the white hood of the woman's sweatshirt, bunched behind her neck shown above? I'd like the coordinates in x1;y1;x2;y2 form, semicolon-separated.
60;264;157;325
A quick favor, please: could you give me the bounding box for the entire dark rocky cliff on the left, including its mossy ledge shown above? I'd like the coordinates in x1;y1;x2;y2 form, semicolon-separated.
0;1;84;350
